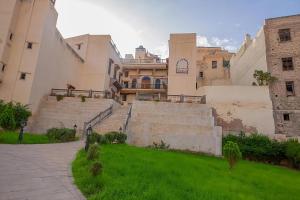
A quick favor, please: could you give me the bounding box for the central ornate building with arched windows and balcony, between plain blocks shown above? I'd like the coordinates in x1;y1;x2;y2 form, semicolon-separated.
121;46;168;103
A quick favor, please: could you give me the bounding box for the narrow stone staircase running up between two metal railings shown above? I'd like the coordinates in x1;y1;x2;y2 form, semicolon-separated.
94;105;129;134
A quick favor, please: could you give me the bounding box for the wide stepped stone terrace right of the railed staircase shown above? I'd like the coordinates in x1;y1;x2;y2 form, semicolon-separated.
127;101;222;156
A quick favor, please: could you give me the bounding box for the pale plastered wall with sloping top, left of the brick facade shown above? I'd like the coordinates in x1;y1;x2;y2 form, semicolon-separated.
230;29;268;85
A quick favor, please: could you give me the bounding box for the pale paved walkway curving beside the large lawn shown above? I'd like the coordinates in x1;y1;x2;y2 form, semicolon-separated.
0;142;84;200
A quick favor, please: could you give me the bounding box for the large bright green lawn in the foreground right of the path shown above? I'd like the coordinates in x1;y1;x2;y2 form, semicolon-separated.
72;145;300;200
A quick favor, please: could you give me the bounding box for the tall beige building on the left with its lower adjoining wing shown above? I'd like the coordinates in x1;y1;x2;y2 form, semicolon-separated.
0;0;122;113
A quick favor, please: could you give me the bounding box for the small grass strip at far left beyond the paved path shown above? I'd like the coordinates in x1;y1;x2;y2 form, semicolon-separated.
0;131;51;144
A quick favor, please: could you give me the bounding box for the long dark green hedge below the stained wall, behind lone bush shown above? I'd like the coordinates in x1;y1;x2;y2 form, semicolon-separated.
223;134;286;164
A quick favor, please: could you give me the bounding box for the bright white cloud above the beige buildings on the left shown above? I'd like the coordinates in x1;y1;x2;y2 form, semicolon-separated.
56;0;143;55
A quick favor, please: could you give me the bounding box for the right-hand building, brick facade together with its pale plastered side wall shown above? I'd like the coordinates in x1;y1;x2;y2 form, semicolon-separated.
231;15;300;136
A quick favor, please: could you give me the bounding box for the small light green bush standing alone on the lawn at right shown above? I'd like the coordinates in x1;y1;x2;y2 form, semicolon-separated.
223;141;242;169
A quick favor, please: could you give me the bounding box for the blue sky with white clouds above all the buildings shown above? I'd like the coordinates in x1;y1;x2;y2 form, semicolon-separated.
56;0;300;58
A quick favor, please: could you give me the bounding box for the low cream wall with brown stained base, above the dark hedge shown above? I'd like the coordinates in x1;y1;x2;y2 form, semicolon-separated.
198;86;275;135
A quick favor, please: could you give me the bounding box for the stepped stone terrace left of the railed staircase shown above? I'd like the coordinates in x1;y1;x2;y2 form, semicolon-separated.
28;96;117;134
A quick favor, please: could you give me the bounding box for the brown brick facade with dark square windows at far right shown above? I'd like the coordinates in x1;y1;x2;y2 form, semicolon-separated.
264;15;300;136
